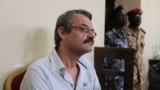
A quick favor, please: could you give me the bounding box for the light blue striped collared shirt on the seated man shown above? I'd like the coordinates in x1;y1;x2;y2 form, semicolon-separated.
20;49;101;90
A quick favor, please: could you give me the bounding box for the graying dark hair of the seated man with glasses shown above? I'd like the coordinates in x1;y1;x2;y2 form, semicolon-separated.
54;9;92;49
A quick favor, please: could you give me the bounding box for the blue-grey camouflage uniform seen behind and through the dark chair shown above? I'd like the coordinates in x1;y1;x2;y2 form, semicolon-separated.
103;28;128;90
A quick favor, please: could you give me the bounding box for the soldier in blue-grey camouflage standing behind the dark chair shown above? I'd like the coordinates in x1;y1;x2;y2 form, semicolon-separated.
103;5;128;90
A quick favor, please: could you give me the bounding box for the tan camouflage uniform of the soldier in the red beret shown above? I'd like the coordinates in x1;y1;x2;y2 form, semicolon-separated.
124;27;145;90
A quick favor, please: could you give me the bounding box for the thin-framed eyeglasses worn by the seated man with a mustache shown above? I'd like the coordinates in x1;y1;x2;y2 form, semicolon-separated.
71;26;97;35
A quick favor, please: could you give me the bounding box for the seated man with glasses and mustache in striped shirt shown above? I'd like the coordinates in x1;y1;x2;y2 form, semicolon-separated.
21;9;101;90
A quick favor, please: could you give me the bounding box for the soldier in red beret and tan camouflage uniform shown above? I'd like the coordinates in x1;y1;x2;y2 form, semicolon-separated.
125;8;146;90
